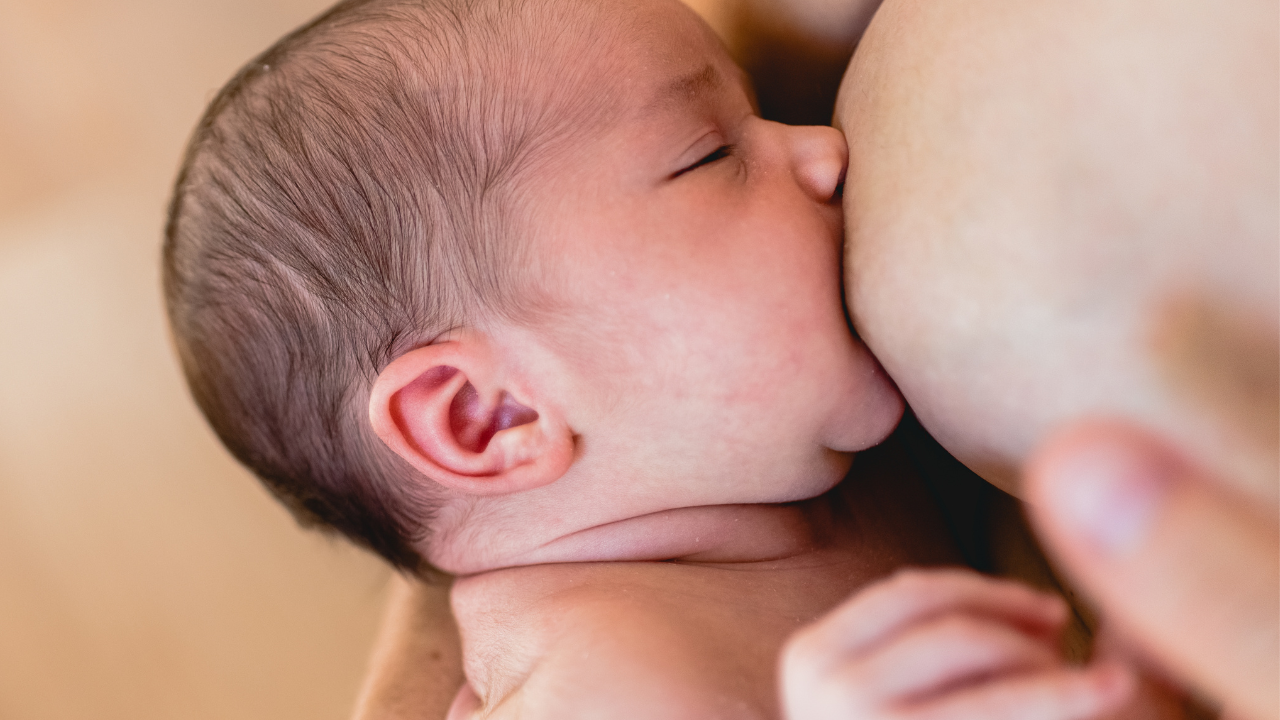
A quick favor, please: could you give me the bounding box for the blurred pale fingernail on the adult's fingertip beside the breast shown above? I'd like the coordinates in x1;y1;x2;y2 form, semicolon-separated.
1044;441;1171;556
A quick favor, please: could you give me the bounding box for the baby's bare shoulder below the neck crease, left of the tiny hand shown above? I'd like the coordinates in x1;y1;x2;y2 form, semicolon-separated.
454;562;790;720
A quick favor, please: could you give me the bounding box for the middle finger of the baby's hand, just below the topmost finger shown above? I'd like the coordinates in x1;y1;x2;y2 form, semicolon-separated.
832;616;1061;703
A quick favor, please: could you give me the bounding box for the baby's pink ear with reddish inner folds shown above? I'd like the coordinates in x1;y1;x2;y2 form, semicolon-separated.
369;333;573;495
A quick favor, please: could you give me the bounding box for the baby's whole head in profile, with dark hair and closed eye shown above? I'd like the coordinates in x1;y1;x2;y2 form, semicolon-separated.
165;0;901;573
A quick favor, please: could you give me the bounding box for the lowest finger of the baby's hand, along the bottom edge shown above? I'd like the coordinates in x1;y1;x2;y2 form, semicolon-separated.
892;664;1134;720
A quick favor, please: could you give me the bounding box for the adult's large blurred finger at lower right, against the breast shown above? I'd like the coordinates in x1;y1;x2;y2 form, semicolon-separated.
1025;421;1280;720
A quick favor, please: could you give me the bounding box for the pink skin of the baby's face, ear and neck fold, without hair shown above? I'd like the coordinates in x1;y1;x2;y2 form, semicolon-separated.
370;0;902;574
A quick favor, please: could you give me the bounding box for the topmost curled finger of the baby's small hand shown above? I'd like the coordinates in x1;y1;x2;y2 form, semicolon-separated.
792;569;1066;661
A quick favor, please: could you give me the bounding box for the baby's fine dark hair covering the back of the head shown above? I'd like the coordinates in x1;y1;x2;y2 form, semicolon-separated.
164;0;609;571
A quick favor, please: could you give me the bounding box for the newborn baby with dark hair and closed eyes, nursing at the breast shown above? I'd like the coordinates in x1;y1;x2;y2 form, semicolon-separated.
165;0;1177;717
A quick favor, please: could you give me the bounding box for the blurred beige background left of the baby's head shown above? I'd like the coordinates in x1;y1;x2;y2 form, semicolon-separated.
0;0;723;720
